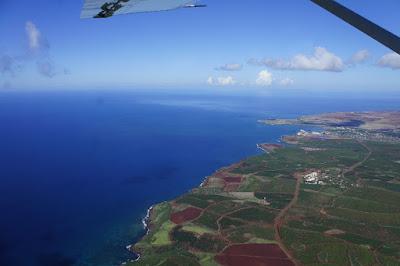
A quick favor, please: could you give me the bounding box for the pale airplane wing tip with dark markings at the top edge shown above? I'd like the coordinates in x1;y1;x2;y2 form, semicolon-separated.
81;0;197;18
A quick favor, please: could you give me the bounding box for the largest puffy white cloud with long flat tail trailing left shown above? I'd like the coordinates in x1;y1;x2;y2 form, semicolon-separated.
249;47;344;72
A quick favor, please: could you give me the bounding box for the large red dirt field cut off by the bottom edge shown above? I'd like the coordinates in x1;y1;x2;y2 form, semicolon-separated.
215;244;295;266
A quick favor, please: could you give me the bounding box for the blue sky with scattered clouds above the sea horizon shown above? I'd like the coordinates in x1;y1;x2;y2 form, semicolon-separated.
0;0;400;92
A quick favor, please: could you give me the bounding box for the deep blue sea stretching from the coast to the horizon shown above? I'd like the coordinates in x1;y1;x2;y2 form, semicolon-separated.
0;90;400;266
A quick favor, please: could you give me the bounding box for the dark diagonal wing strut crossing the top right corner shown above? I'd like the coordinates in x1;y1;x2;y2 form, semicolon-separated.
311;0;400;54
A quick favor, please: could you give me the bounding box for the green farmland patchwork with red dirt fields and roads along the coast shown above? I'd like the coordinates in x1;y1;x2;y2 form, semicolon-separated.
127;112;400;266
